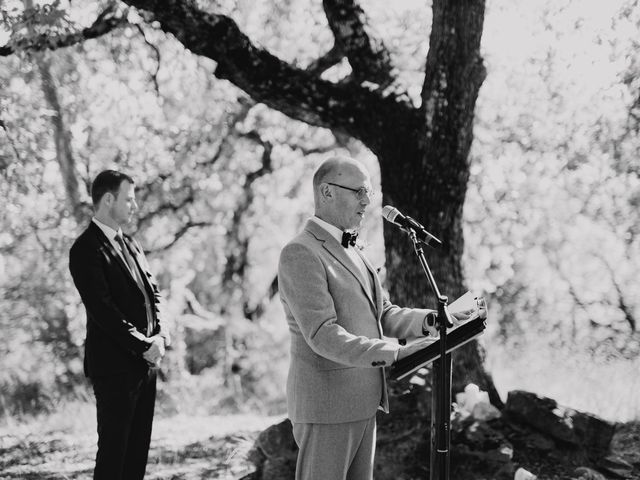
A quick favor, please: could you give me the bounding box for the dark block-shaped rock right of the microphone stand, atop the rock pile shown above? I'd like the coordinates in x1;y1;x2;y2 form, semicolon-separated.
504;390;615;458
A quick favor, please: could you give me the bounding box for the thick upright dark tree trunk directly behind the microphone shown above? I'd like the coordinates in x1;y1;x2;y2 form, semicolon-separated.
376;1;502;406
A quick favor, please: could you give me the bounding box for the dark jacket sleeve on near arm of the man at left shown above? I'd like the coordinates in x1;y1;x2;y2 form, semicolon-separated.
69;238;151;355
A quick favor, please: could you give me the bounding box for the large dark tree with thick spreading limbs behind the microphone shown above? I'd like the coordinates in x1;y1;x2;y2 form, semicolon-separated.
1;0;500;403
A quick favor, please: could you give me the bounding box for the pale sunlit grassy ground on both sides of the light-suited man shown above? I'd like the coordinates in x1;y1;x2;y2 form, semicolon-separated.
0;348;640;480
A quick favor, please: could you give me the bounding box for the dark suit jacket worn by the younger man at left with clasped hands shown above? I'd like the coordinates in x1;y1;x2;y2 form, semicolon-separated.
69;221;163;377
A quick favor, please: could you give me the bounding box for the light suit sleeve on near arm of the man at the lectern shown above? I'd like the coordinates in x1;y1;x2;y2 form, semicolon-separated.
278;243;400;367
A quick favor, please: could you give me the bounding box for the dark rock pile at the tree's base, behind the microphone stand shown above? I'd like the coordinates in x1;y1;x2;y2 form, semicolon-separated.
247;388;632;480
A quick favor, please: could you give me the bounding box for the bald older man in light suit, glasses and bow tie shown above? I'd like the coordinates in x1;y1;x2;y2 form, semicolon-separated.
278;157;464;480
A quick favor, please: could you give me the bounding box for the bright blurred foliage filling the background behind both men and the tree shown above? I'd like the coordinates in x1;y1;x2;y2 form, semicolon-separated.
0;1;640;416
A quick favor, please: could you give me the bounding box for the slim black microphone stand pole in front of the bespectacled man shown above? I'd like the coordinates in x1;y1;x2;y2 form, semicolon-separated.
406;228;453;480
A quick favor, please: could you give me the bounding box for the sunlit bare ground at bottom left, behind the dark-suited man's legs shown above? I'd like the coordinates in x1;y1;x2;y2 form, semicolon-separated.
0;415;281;480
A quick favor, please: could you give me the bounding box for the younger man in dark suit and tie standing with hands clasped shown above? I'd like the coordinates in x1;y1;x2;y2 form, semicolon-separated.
69;170;169;480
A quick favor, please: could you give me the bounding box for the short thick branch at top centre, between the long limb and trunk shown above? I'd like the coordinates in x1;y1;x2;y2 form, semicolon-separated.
322;0;394;87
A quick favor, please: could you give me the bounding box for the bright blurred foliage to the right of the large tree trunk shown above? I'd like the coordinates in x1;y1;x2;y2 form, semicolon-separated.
465;2;640;418
